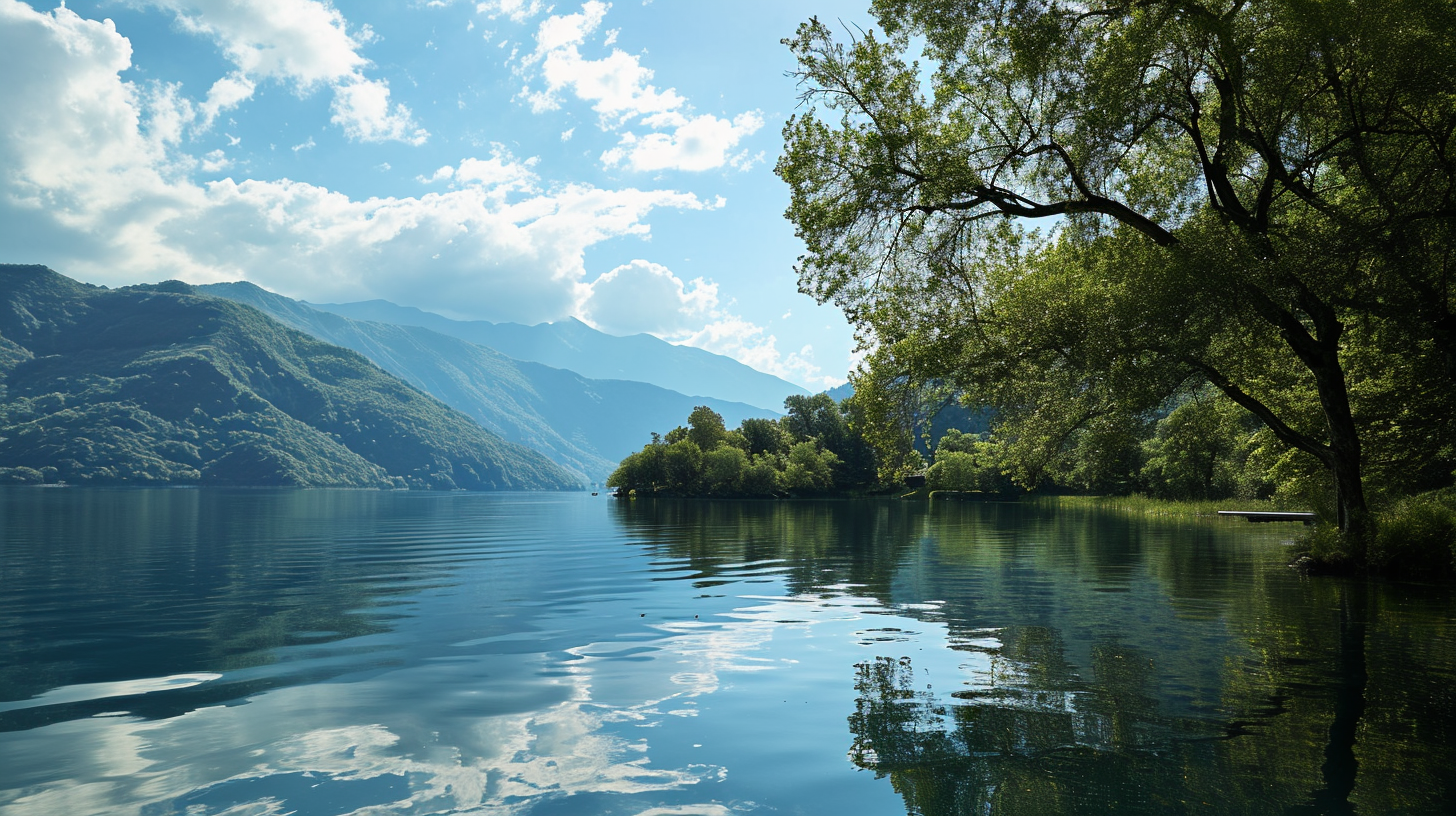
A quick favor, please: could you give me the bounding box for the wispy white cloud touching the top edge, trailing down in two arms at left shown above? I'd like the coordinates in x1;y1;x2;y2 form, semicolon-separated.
146;0;430;144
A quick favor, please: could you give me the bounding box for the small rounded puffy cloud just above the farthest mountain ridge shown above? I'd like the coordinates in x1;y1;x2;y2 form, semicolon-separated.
581;259;718;335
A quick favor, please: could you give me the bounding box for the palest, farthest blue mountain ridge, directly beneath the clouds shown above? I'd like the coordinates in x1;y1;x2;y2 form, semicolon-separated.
310;300;808;411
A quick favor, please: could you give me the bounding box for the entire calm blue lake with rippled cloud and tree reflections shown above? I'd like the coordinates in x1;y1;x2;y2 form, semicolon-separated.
0;488;1456;816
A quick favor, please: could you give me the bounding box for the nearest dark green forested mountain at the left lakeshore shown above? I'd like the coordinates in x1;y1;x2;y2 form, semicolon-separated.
0;265;579;490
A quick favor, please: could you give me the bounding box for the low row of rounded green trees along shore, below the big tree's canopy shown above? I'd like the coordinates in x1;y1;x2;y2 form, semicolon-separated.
607;373;1397;510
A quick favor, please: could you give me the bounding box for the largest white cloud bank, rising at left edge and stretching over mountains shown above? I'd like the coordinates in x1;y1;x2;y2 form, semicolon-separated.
0;0;718;321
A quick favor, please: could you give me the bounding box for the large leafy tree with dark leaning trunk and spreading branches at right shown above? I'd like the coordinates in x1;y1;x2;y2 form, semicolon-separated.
778;0;1456;541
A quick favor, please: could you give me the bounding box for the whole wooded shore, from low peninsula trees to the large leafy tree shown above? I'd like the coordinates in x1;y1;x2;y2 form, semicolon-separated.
613;0;1456;585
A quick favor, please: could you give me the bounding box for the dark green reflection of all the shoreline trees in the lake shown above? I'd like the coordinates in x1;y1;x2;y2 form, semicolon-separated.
617;501;1456;816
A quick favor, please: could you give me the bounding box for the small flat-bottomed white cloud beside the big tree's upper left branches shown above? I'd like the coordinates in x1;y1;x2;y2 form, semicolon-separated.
601;111;763;172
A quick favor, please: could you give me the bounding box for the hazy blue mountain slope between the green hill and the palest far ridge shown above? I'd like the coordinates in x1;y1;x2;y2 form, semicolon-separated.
198;283;776;482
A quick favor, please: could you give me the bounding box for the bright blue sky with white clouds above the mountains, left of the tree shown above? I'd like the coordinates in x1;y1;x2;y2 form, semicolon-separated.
0;0;868;389
